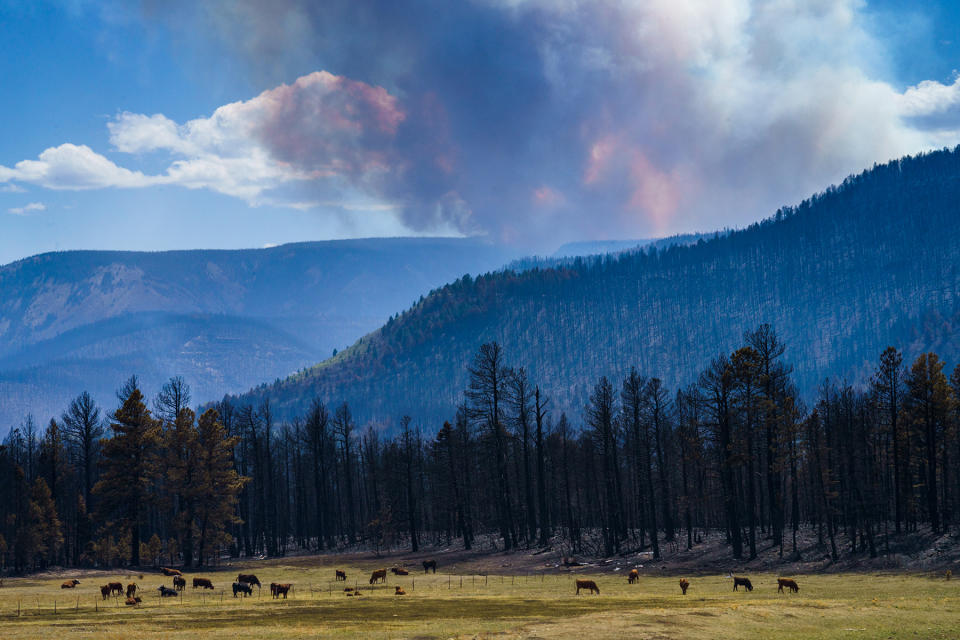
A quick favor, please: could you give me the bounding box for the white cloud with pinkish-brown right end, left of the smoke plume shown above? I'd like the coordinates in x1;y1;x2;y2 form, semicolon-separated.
0;71;404;206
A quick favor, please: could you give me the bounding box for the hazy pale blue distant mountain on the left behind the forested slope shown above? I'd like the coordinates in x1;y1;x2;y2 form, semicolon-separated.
0;238;517;434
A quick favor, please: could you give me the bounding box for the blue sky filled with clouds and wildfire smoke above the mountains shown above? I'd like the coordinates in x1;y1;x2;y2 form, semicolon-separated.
0;0;960;263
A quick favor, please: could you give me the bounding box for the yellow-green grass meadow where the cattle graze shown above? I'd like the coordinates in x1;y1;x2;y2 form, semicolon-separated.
0;559;960;640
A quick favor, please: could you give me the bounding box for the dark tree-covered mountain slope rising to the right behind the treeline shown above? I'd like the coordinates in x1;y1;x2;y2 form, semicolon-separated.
231;147;960;425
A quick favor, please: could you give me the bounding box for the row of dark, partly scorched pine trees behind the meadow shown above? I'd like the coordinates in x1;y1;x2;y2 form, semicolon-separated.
0;325;960;571
